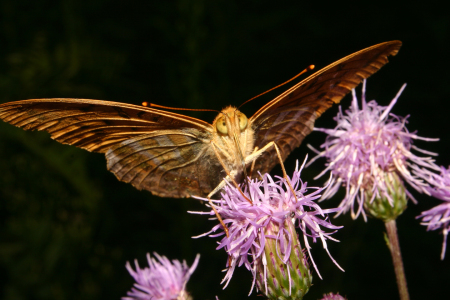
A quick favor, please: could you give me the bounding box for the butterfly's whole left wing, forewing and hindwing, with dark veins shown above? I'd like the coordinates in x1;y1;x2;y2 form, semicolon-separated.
0;99;222;197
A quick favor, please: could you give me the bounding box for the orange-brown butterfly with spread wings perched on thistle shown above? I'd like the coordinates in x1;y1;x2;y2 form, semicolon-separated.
0;41;401;198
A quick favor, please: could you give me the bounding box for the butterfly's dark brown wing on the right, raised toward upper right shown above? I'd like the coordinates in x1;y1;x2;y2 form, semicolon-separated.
249;41;402;176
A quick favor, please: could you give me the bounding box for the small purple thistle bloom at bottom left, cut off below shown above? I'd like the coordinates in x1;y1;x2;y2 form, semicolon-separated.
122;253;200;300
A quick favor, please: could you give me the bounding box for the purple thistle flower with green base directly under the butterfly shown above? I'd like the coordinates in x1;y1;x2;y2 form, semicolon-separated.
191;159;342;299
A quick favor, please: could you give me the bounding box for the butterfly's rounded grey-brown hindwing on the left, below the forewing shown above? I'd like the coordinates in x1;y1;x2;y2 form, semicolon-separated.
106;129;226;198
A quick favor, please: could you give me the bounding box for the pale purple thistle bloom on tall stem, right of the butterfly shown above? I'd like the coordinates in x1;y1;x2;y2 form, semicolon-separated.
309;81;438;219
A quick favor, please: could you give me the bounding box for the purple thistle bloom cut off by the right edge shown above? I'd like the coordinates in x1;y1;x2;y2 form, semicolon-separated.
417;166;450;259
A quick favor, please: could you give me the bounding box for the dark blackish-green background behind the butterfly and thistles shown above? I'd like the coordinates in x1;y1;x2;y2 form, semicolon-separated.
0;0;450;300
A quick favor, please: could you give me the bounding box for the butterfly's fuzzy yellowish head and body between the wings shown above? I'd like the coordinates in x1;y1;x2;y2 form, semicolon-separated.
212;106;255;177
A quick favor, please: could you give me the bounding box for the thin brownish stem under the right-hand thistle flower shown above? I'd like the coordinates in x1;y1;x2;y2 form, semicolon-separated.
384;220;409;300
